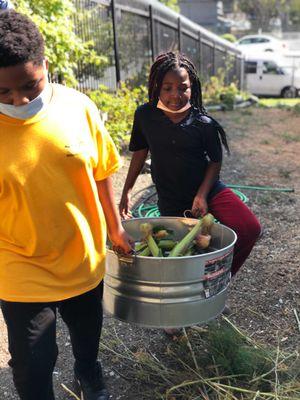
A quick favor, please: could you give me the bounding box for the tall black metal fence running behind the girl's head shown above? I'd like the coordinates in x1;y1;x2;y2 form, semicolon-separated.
75;0;243;91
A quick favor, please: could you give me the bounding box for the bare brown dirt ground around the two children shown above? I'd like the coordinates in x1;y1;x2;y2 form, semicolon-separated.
0;108;300;400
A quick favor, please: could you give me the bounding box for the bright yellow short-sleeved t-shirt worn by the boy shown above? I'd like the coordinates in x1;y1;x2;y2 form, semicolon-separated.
0;85;120;302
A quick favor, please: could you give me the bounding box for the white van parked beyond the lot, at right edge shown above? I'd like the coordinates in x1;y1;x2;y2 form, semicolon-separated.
245;55;300;98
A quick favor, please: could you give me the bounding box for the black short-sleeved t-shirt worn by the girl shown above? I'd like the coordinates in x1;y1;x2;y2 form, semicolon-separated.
129;103;225;215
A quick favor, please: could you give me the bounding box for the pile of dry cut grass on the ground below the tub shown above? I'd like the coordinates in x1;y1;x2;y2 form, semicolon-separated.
102;317;300;400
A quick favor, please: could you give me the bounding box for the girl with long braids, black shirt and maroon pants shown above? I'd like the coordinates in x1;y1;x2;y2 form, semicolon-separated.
120;52;261;274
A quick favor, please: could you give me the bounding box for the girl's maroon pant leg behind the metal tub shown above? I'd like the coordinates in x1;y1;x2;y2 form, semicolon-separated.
208;188;261;275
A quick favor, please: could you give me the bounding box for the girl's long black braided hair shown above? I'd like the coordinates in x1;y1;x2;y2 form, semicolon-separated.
148;51;230;154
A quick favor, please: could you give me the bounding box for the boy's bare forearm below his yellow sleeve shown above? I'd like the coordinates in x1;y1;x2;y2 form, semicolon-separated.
96;177;122;235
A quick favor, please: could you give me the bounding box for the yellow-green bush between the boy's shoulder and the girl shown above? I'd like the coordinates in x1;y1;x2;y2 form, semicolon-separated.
88;84;147;149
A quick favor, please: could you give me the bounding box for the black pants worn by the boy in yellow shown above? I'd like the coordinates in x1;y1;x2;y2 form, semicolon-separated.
1;282;103;400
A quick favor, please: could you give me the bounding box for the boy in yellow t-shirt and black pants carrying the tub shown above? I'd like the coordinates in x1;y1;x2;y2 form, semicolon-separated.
0;10;131;400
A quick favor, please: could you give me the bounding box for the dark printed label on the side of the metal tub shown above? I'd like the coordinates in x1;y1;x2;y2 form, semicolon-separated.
203;250;233;298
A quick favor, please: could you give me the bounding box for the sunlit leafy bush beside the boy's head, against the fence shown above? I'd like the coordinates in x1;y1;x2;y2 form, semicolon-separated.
14;0;107;86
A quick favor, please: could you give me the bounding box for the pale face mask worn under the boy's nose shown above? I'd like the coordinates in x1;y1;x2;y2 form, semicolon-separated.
0;67;52;120
